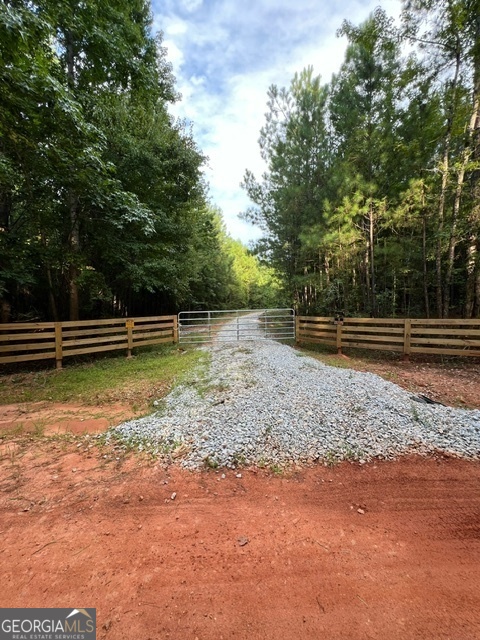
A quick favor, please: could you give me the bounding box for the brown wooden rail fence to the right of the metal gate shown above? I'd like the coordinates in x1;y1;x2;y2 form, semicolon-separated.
296;316;480;359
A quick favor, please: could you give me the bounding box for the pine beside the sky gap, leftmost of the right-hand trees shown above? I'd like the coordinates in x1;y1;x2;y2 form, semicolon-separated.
242;68;329;307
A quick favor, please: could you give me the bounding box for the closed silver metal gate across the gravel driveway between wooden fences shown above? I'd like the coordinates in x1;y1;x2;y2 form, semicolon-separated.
178;309;295;344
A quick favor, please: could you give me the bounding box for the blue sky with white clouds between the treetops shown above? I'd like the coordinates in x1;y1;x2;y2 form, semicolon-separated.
152;0;400;244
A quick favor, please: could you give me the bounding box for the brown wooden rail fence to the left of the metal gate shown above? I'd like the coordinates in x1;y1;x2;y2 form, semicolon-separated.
0;316;178;369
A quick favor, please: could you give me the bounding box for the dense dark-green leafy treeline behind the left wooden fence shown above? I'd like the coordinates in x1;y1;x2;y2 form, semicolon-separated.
0;0;276;322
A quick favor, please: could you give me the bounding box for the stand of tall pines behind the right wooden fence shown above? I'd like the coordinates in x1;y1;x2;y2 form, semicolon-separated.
243;0;480;318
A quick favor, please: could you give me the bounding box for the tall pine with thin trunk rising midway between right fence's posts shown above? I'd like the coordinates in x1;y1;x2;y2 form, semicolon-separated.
329;9;402;315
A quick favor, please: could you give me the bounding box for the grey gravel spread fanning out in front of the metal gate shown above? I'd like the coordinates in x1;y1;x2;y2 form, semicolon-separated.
108;316;480;469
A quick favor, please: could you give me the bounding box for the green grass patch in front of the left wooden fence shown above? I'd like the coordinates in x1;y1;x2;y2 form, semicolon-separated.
0;345;206;406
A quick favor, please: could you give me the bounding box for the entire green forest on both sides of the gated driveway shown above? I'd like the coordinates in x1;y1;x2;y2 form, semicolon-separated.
0;0;480;322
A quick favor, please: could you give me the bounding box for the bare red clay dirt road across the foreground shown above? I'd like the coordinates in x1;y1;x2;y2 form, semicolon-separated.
0;438;480;640
